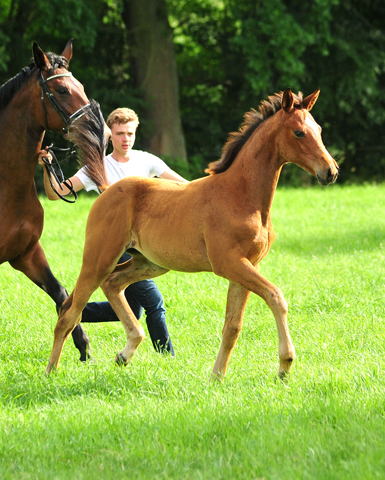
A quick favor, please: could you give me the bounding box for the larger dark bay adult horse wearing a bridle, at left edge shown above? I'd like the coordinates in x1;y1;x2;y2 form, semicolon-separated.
0;40;104;360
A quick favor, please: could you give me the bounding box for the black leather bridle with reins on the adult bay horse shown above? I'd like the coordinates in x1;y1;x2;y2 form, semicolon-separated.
39;71;90;203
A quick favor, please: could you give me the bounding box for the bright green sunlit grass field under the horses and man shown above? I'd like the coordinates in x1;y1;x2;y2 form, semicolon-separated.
0;185;385;480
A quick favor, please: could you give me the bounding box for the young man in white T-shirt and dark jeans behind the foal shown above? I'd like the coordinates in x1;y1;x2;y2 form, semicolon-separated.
39;108;187;355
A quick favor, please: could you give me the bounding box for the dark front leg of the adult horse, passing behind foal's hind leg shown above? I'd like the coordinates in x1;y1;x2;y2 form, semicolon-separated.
9;242;90;362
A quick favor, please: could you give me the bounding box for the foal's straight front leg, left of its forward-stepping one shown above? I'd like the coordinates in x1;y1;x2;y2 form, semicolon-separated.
212;282;250;380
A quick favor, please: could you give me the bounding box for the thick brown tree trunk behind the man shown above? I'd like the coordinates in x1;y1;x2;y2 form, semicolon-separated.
123;0;187;161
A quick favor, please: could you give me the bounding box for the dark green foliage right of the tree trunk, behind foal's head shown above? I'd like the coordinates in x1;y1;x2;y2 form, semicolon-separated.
169;0;385;179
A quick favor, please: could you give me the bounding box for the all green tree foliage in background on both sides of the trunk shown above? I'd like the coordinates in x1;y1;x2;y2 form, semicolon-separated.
0;0;385;185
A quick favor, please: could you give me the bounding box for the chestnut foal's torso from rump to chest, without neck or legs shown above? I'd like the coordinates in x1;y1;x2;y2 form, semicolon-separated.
86;173;269;272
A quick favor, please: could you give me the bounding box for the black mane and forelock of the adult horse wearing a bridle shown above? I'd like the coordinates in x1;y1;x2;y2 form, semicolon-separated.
0;52;68;110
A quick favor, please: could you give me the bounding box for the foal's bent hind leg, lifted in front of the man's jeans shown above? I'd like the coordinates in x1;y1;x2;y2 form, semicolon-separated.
102;253;168;365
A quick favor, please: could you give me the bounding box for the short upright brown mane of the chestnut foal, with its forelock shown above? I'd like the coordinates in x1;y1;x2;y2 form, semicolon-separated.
205;92;303;175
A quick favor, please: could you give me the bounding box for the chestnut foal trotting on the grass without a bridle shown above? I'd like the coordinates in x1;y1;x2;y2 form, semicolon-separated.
46;89;338;378
